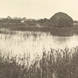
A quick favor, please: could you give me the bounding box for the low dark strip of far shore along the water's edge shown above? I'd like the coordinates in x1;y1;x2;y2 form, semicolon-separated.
0;25;78;36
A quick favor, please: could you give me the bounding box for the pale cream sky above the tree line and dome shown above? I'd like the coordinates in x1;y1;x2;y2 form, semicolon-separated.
0;0;78;20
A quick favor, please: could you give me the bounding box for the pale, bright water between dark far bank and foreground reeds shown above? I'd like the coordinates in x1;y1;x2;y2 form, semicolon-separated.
0;32;78;58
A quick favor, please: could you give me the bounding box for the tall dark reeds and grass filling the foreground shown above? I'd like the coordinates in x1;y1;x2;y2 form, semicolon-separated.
0;47;78;78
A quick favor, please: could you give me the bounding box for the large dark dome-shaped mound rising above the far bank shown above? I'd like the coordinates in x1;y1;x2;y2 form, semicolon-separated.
50;12;73;27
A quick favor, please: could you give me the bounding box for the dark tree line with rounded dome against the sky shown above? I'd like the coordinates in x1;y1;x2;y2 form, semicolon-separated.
0;12;77;27
